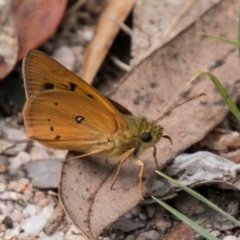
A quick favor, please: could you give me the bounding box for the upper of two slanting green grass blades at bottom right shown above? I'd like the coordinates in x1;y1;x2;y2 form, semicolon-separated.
156;171;240;226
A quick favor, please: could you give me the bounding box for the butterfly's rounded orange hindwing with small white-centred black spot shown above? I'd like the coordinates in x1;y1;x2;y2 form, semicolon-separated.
23;90;118;152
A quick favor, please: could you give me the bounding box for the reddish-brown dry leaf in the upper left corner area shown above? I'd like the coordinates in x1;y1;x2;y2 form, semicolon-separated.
14;0;67;59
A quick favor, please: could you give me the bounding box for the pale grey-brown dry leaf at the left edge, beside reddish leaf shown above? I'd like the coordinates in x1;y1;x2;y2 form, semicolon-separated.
0;0;18;80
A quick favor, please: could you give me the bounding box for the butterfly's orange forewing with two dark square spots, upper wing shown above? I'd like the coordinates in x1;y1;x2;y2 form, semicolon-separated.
23;50;127;130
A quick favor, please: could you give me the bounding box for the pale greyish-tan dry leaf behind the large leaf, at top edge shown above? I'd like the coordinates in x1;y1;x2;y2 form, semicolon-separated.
131;0;221;65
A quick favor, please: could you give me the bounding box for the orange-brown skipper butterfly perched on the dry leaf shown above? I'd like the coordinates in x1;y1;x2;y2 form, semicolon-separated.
23;50;202;199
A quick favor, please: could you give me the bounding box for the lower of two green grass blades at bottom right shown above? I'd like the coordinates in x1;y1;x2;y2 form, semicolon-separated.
152;196;218;240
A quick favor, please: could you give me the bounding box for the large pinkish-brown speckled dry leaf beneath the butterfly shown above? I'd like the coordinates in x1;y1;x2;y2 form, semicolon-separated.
60;0;240;239
